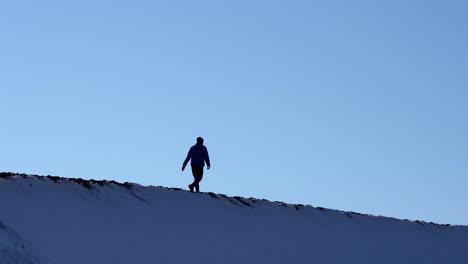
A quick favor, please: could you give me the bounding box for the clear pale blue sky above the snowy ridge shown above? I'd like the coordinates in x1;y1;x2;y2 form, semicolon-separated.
0;0;468;225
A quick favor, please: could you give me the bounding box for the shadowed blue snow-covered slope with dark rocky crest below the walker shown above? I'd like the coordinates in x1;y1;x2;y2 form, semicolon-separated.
0;173;468;264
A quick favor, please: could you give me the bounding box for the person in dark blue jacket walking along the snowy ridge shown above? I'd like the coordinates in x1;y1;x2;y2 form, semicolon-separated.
182;137;211;192
